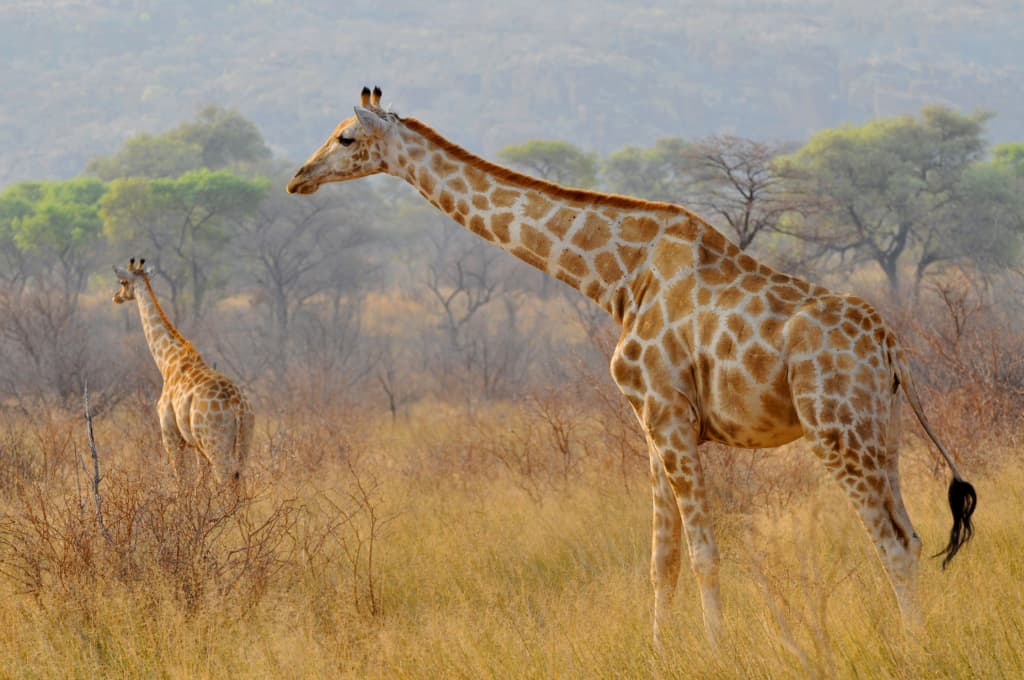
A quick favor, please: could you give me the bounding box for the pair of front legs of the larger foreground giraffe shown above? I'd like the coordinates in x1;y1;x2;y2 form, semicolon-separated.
641;396;722;644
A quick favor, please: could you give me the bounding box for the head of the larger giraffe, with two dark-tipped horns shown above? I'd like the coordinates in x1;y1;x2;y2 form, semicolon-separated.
288;87;398;194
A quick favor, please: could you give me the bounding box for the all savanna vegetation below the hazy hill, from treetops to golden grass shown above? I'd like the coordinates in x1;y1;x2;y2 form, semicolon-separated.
0;107;1024;678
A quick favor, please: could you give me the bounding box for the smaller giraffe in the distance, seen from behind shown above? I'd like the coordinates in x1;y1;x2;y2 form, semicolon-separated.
114;258;254;487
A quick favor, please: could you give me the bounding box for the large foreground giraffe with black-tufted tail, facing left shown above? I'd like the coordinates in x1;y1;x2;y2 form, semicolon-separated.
288;88;977;644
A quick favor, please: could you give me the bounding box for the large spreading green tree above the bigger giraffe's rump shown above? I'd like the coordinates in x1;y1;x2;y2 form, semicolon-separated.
779;107;989;294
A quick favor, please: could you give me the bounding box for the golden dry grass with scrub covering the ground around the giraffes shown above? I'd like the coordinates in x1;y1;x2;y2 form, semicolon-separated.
0;394;1024;678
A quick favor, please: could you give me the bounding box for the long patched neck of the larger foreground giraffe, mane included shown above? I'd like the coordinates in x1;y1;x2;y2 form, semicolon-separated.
386;118;710;321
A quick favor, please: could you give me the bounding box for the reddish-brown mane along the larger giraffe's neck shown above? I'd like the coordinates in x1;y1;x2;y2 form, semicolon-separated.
398;118;702;221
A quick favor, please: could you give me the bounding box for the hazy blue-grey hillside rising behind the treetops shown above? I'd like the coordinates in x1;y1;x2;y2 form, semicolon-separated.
0;0;1024;185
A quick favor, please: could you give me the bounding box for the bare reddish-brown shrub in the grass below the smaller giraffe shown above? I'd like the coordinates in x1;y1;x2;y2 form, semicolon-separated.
0;470;299;611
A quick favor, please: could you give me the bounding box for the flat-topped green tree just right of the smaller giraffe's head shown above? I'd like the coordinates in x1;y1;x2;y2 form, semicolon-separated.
100;169;267;324
